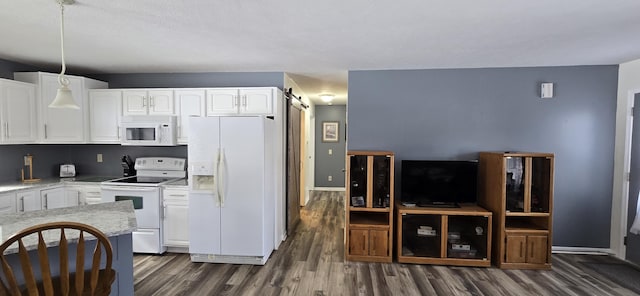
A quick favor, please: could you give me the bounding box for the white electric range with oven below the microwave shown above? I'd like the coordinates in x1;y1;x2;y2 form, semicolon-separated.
101;157;186;254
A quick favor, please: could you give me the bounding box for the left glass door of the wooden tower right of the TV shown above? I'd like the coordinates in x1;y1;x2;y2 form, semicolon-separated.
505;157;525;212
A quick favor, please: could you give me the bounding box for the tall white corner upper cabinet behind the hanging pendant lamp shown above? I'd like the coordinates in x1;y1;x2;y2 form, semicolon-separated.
14;72;108;144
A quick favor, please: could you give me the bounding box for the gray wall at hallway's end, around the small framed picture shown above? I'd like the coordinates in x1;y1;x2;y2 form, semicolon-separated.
314;105;347;187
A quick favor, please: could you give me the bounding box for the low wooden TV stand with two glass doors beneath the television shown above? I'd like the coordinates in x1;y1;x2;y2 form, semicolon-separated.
396;203;492;267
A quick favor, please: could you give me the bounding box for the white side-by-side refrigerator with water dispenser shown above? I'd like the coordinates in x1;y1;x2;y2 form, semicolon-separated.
187;116;276;265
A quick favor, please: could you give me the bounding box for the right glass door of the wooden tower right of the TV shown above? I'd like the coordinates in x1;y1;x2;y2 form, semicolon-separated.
531;157;551;213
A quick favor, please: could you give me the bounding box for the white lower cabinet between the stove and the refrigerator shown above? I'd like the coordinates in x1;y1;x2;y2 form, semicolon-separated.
162;189;189;248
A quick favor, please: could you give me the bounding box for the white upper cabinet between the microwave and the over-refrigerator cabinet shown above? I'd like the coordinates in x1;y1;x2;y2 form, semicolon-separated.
174;89;205;144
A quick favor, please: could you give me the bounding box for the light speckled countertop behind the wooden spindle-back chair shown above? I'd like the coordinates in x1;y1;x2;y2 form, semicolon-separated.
0;201;137;254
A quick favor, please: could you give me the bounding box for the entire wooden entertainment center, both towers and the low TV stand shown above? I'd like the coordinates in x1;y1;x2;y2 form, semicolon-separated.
345;151;554;269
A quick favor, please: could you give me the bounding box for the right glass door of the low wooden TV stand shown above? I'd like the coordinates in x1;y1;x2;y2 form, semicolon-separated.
447;216;489;259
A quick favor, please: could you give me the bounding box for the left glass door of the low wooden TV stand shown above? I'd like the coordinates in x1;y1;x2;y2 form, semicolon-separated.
401;214;442;258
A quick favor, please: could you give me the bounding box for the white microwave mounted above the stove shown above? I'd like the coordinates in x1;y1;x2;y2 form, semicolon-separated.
120;115;177;146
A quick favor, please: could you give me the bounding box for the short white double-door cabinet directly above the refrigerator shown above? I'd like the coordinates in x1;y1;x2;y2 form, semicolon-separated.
206;87;275;116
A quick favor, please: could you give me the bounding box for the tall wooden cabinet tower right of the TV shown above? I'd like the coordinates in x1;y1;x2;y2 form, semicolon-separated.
478;152;554;269
